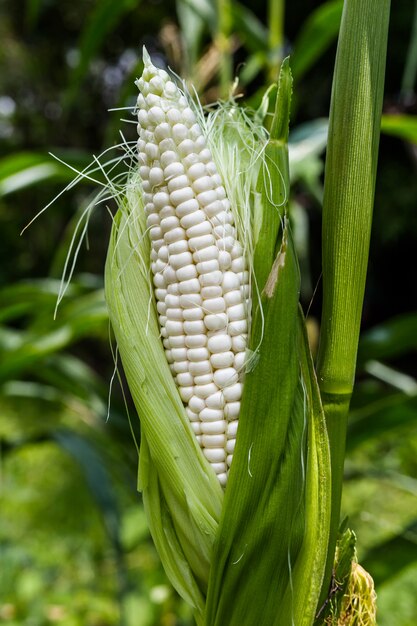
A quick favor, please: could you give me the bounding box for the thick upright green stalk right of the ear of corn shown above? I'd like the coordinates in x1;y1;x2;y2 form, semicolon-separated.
317;0;390;608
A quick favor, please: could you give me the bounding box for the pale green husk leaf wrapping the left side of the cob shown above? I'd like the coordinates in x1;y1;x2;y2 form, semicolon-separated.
105;179;223;619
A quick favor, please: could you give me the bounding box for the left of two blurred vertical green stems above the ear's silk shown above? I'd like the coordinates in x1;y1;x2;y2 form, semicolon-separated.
216;0;233;98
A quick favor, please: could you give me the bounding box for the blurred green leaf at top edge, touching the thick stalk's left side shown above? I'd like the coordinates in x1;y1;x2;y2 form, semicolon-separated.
291;0;343;80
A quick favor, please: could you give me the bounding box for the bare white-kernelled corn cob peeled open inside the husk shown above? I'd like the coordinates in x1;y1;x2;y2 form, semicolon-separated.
137;51;249;485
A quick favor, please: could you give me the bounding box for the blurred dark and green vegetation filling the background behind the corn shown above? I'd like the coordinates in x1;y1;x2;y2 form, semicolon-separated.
0;0;417;626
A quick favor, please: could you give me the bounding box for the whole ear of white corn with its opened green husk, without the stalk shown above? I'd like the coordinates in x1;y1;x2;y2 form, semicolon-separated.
106;52;329;626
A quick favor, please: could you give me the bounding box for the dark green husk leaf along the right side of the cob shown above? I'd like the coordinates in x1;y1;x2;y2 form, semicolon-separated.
206;63;330;626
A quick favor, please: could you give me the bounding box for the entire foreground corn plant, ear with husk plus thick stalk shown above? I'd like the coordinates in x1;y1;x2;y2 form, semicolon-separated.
102;0;389;626
